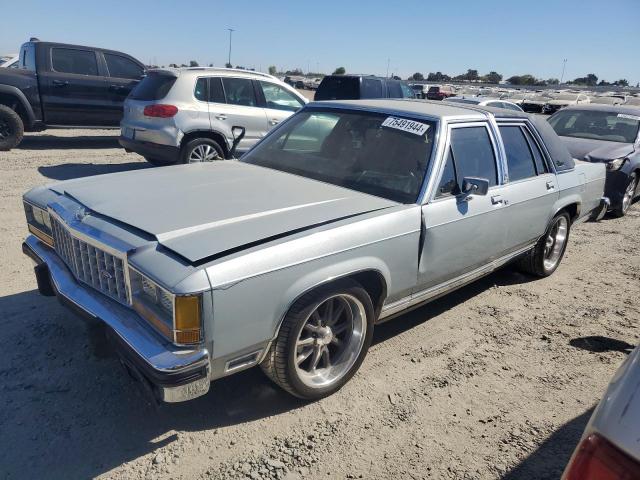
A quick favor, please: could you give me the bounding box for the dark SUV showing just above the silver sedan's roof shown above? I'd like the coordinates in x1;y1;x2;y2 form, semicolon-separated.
314;75;415;100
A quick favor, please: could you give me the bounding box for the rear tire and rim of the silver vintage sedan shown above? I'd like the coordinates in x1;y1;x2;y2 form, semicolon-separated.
517;211;571;278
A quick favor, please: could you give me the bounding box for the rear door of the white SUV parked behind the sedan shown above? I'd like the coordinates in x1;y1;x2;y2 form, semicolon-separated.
209;77;269;151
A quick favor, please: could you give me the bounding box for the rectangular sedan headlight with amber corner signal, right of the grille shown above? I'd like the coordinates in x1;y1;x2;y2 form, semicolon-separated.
129;268;203;345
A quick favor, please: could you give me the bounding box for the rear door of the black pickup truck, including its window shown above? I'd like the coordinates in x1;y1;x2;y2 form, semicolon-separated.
38;47;110;126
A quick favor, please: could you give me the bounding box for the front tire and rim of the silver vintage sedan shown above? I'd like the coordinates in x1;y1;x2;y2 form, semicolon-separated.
261;279;374;400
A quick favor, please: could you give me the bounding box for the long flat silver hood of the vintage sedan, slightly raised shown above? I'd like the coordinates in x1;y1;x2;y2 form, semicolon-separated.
50;161;397;262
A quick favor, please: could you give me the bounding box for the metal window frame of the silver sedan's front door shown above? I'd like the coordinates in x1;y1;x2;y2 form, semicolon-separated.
422;120;508;205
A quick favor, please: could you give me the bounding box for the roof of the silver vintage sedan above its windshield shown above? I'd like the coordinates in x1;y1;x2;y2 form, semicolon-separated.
309;98;530;120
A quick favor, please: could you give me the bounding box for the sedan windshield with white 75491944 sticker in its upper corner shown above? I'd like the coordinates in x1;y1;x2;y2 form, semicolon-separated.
241;109;436;203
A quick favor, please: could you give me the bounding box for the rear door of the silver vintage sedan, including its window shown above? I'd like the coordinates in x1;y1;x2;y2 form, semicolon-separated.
498;122;558;252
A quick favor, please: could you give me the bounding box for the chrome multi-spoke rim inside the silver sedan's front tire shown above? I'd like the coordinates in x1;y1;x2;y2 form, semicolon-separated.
294;294;367;388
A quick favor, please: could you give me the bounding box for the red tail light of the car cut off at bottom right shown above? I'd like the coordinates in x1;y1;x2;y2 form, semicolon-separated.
566;434;640;480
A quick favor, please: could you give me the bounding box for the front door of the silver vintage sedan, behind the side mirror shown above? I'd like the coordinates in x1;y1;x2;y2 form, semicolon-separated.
416;122;506;292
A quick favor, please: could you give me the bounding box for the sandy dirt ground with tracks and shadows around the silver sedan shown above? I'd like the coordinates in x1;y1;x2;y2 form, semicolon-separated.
0;130;640;480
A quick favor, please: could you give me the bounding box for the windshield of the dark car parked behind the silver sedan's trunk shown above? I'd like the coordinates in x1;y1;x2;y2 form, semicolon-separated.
549;110;640;143
